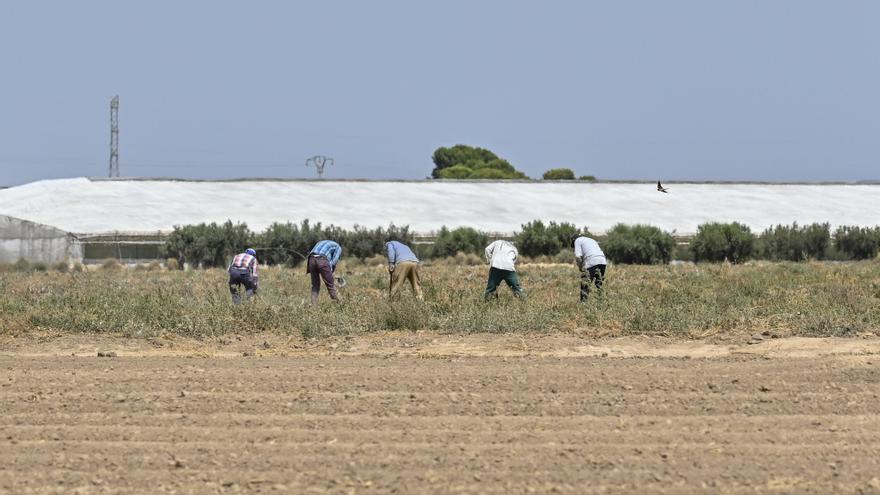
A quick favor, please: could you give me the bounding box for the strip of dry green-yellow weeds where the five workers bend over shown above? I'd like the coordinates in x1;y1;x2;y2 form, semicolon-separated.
0;261;880;337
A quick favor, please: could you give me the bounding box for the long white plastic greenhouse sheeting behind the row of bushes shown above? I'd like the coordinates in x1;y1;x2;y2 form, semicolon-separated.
0;178;880;235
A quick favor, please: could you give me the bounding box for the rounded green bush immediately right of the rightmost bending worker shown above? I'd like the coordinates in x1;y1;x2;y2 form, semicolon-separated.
602;224;675;265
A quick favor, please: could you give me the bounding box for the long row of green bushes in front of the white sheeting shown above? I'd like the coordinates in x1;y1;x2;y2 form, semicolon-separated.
162;220;880;267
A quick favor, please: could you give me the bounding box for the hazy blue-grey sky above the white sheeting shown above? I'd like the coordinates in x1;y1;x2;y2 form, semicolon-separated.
0;0;880;185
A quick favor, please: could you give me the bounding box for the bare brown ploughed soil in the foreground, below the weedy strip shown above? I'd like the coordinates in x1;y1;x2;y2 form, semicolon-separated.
0;334;880;493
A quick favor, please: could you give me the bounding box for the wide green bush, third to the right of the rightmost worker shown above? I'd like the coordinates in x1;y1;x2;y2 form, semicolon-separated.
757;223;831;261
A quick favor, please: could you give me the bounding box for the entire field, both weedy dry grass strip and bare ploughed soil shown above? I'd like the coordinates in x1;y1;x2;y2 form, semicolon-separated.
0;263;880;493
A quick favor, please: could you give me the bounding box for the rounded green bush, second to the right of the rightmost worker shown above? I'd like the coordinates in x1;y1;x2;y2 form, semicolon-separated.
691;222;755;263
